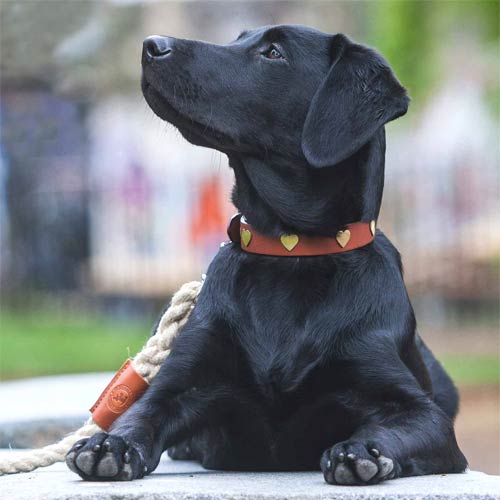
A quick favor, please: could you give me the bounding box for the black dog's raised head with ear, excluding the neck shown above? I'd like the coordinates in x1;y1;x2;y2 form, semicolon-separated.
142;26;408;167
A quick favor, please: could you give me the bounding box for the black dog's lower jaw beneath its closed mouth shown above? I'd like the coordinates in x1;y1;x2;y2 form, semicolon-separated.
141;75;233;149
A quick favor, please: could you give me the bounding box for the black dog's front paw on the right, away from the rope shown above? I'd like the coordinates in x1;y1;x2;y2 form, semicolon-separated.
320;441;397;485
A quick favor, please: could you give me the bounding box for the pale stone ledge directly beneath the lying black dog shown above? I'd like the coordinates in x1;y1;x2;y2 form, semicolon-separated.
0;450;500;500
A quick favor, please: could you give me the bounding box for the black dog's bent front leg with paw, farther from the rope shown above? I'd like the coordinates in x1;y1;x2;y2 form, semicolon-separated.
320;340;467;485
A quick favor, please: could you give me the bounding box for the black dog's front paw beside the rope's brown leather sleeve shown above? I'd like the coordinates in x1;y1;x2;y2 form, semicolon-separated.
66;432;148;481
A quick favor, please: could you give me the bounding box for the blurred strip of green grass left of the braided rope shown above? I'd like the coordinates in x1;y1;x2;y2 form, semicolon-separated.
0;311;148;380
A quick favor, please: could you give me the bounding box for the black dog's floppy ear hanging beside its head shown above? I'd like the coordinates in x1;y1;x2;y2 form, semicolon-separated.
302;34;409;167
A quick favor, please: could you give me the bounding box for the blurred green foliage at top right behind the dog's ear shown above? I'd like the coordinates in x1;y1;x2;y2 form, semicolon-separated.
365;0;500;103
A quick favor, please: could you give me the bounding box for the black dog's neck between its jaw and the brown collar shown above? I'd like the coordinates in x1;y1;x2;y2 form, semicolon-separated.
229;129;385;236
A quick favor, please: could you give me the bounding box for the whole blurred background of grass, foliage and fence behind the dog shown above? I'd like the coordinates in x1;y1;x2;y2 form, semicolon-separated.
0;0;500;473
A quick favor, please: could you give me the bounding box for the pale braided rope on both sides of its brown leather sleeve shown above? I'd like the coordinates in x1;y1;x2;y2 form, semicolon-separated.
0;281;202;476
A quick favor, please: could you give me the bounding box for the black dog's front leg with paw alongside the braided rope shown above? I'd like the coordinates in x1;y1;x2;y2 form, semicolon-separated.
66;312;231;481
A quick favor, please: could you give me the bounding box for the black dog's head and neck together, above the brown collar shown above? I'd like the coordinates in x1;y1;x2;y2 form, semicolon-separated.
142;26;409;234
